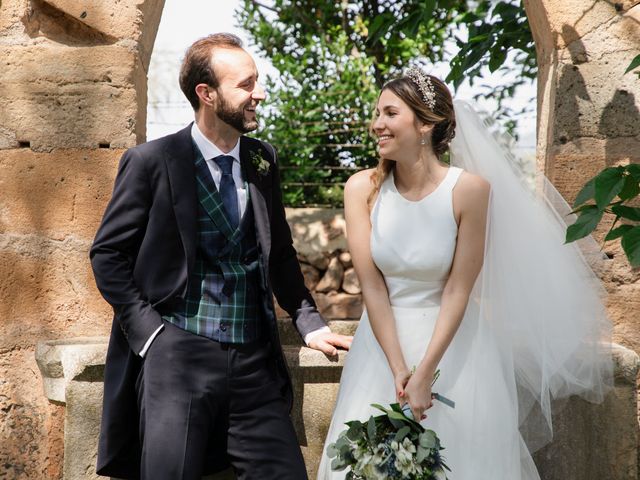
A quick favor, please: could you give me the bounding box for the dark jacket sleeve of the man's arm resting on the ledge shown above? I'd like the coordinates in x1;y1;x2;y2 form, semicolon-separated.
269;145;327;338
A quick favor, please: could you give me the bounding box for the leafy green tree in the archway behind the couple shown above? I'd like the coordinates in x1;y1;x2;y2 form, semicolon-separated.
237;0;536;206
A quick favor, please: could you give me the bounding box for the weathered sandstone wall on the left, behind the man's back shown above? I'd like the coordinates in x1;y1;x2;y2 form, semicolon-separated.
0;0;164;480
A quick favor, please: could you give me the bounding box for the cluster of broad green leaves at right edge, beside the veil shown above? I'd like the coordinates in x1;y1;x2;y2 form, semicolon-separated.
566;164;640;267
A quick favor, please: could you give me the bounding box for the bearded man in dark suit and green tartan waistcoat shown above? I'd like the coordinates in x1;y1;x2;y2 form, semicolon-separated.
91;33;350;480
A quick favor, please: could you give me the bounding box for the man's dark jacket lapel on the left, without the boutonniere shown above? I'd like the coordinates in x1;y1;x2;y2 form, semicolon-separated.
165;124;198;278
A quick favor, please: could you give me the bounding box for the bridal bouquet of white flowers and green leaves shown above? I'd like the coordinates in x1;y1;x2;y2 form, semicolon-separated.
327;376;455;480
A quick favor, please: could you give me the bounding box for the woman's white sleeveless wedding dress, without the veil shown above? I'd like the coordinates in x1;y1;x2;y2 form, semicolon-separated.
318;167;539;480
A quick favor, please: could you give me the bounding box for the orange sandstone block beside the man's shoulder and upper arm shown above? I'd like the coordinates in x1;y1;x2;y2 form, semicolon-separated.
0;148;122;239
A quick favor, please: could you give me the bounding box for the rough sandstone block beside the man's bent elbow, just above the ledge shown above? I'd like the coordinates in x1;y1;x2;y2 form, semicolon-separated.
0;235;111;346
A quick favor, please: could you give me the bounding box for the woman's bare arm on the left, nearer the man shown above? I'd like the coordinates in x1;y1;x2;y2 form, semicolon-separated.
344;170;409;395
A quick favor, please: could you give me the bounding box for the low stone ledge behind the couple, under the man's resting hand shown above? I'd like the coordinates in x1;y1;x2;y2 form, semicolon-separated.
36;338;640;480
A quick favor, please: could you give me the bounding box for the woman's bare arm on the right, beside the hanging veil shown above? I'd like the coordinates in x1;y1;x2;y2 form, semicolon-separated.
406;172;490;418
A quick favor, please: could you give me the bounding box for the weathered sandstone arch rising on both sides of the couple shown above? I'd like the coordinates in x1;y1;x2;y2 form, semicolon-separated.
0;0;640;479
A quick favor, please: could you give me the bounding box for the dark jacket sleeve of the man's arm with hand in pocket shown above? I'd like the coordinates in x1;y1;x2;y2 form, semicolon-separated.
90;149;162;353
